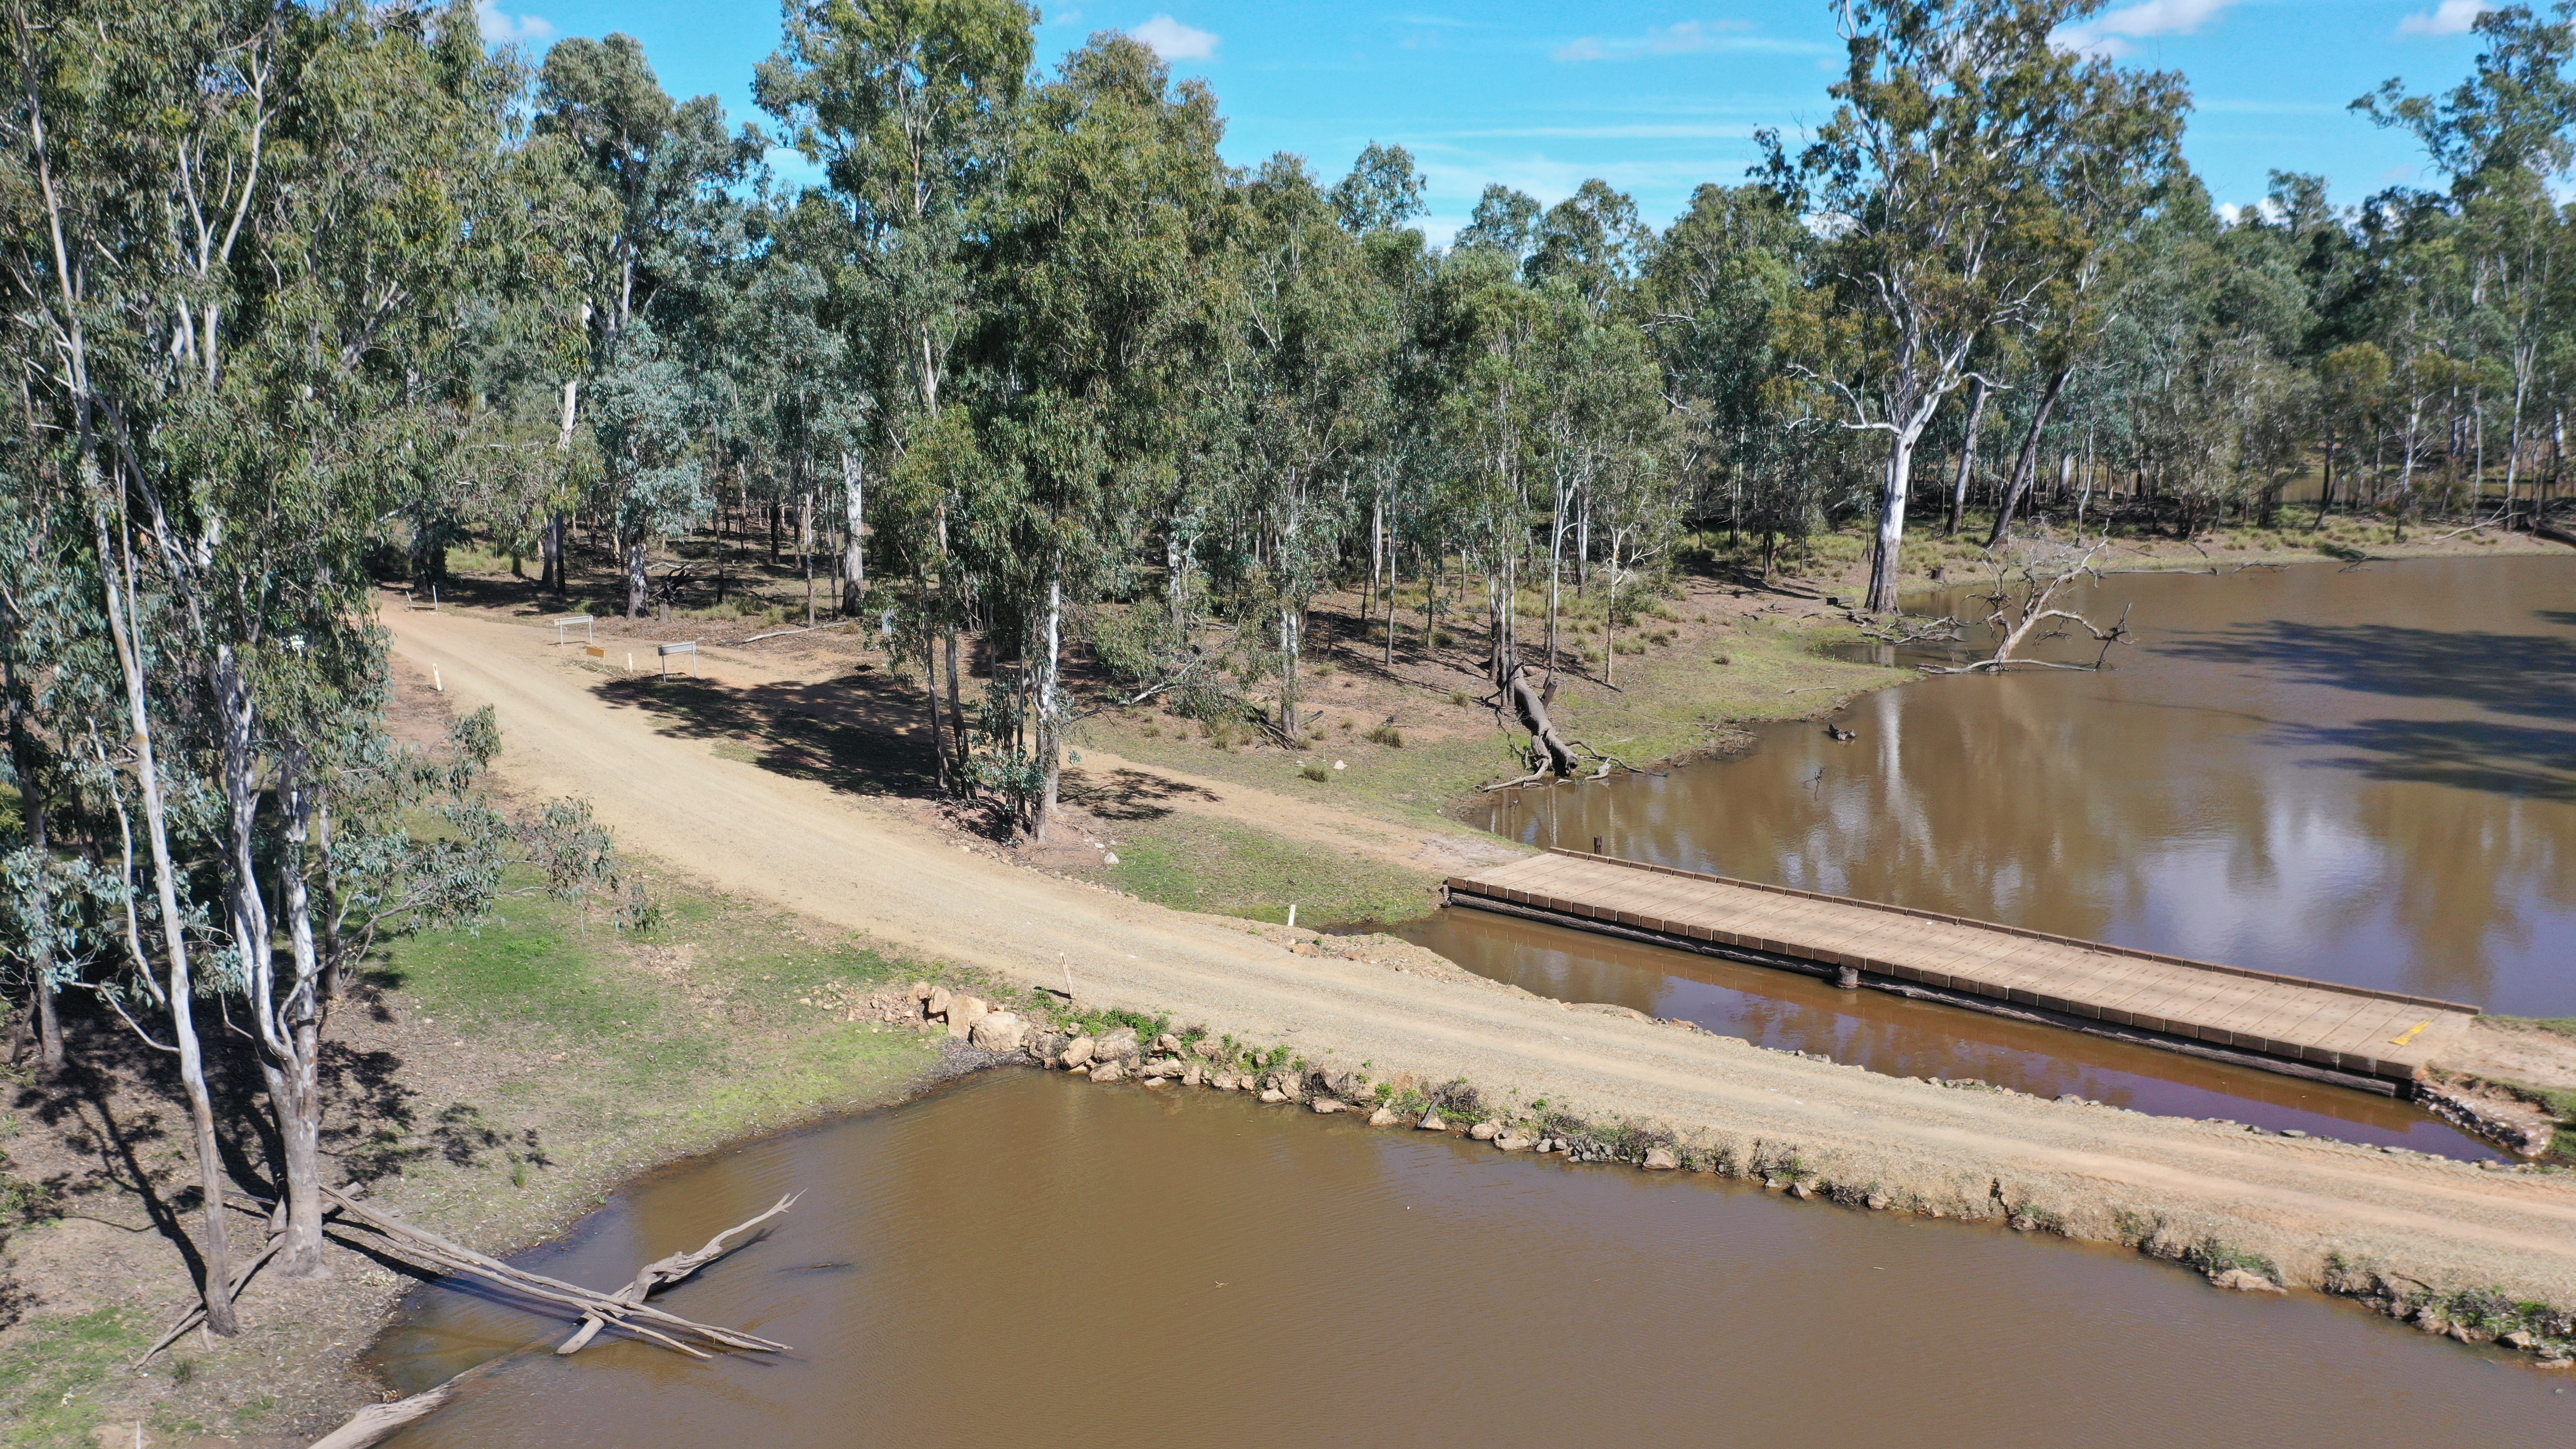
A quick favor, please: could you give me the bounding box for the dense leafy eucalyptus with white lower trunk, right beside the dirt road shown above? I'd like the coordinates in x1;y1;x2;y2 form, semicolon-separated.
966;33;1226;838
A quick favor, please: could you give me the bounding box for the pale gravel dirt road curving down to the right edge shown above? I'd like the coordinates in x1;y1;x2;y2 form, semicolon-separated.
389;603;2576;1304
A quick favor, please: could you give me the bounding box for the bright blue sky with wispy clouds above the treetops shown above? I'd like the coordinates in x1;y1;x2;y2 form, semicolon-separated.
479;0;2524;240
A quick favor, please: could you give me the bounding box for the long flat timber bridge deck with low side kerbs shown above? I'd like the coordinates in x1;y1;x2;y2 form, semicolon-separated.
1448;851;2478;1096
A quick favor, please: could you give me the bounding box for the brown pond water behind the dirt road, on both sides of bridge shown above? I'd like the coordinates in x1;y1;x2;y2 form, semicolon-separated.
1401;557;2576;1155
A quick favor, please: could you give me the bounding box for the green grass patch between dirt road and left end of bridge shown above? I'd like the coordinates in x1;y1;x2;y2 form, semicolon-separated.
1108;815;1437;926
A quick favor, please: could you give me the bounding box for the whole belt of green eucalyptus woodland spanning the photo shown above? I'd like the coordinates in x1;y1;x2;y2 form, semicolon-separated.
0;0;2576;1330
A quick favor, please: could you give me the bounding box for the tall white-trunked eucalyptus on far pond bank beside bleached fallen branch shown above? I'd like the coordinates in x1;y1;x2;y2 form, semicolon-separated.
1762;0;2195;611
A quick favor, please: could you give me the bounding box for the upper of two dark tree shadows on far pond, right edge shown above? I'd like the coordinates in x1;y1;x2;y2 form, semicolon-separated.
2156;613;2576;716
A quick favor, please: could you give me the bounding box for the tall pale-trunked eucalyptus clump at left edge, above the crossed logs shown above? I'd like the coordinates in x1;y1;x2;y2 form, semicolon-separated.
8;2;585;1310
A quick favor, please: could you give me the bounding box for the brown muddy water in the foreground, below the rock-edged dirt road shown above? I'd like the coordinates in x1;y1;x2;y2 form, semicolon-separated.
378;1070;2576;1449
